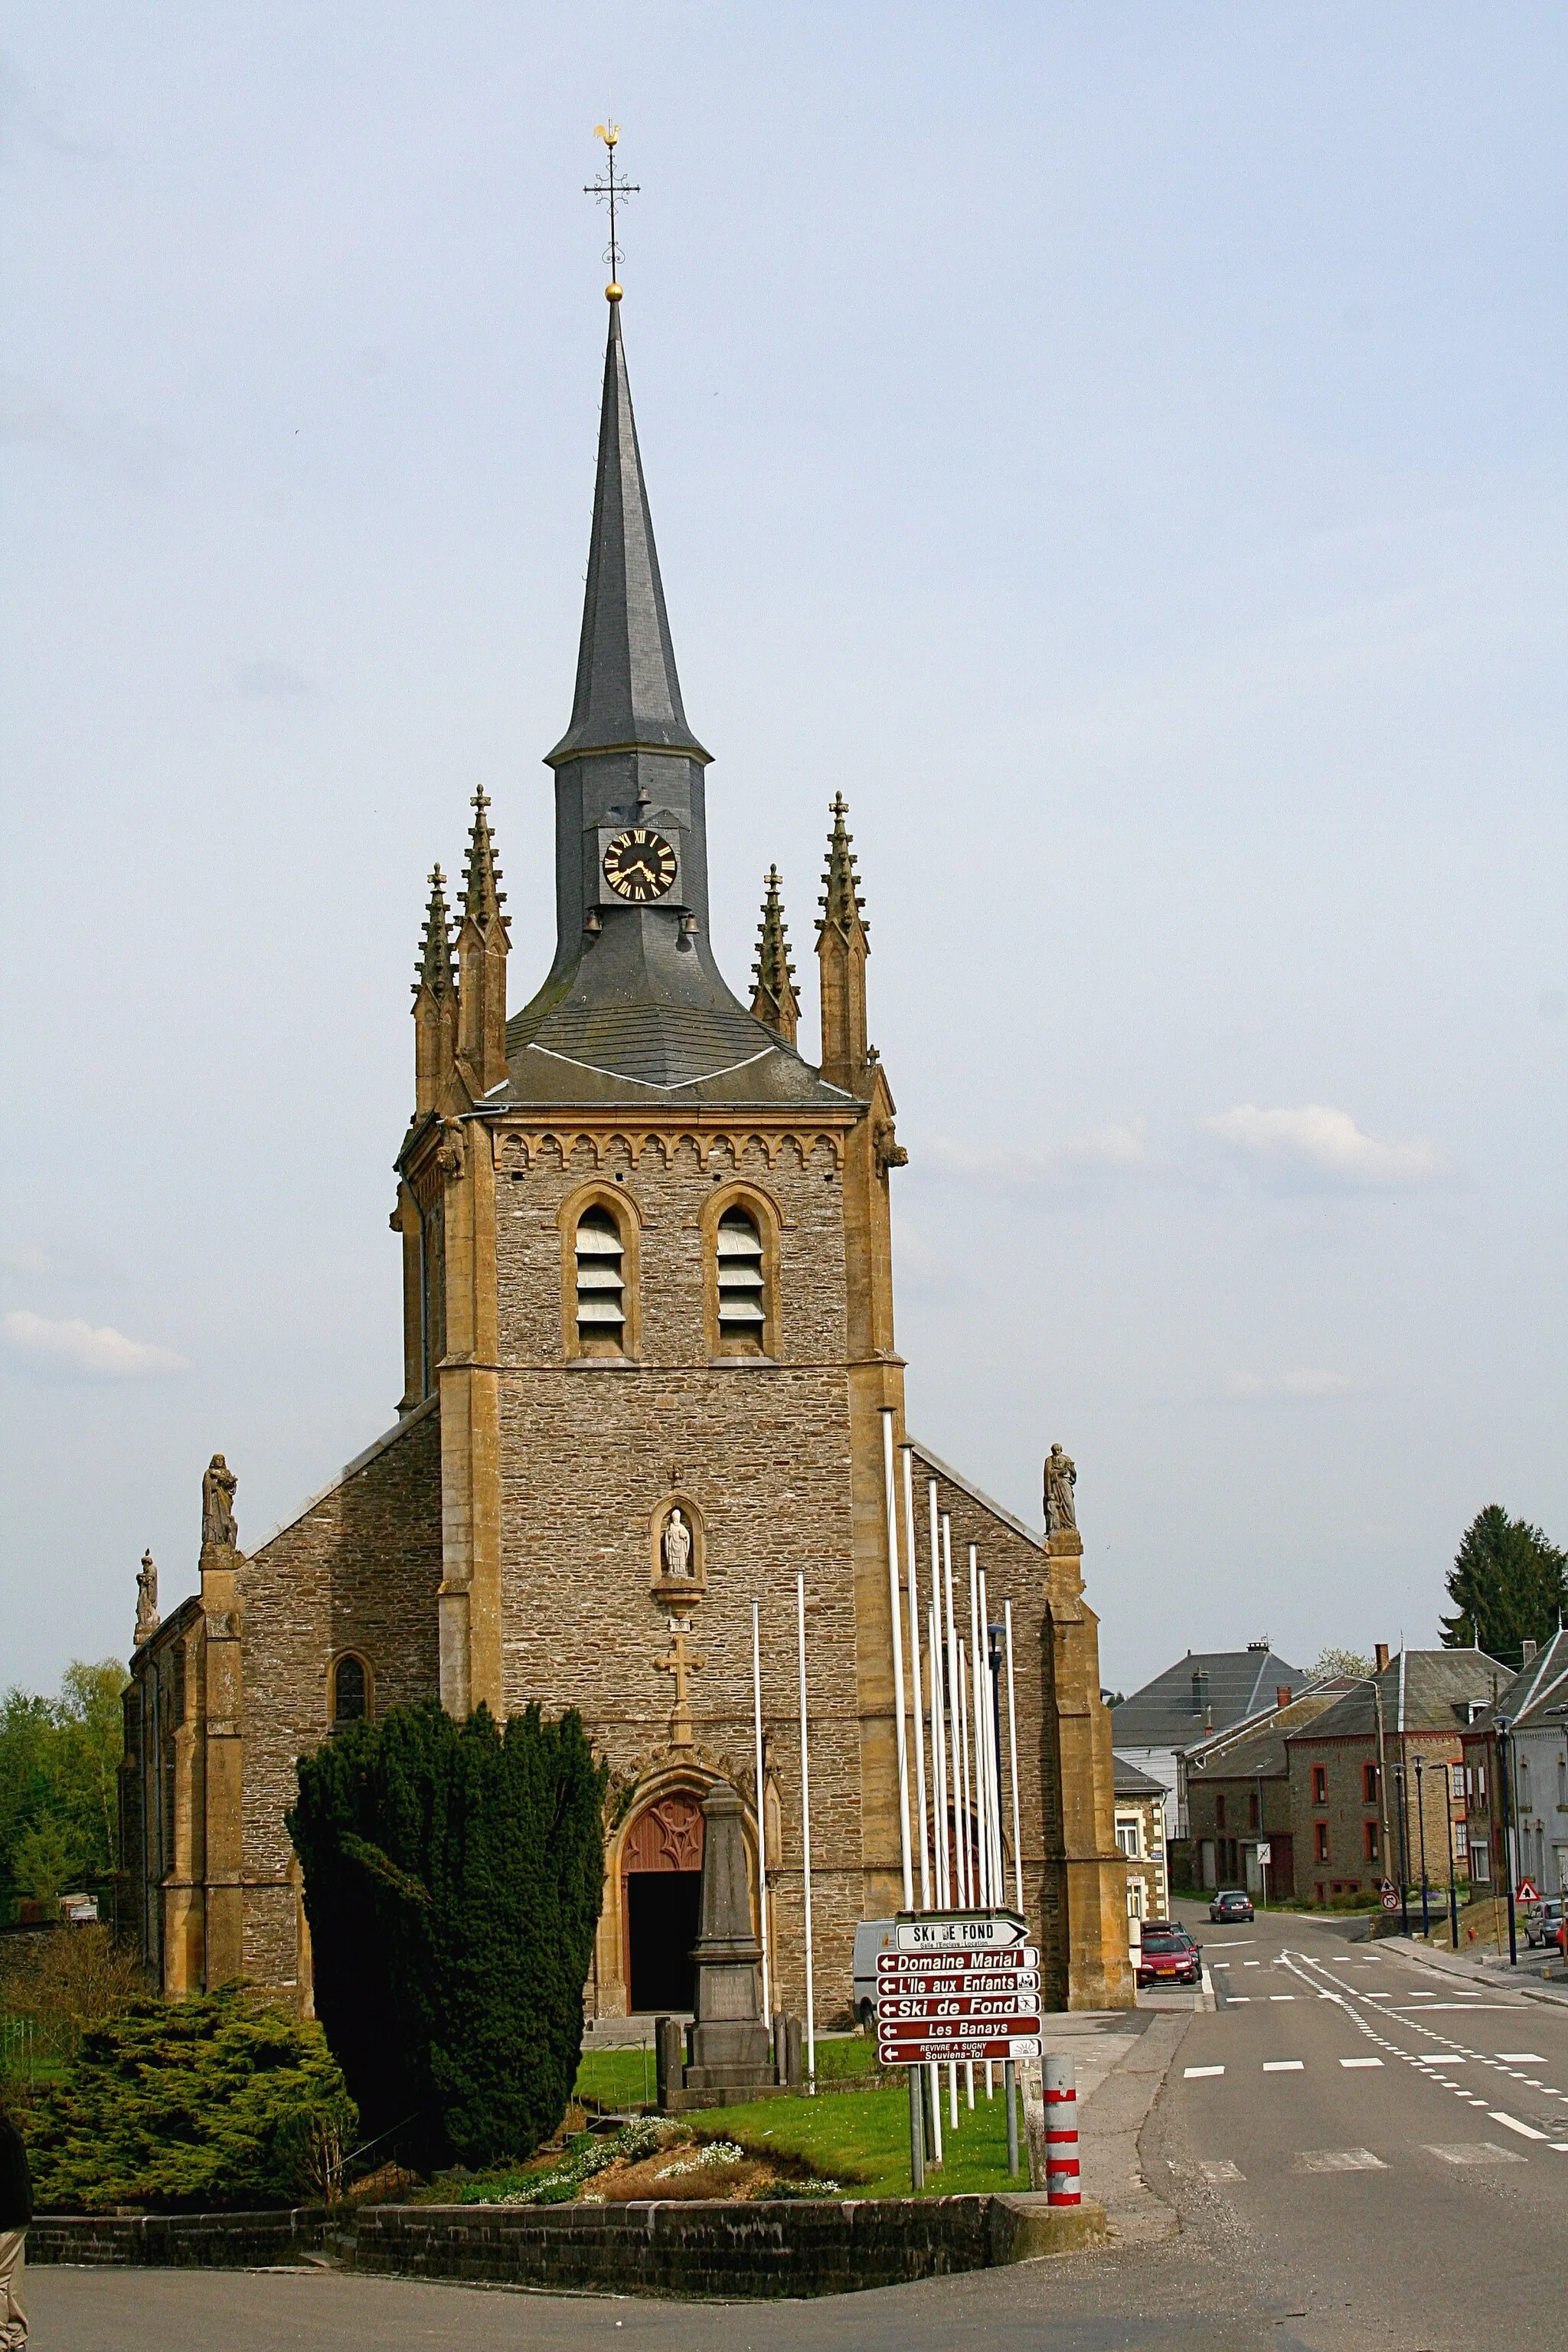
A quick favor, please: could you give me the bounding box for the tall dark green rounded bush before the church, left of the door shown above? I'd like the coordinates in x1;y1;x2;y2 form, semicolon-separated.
289;1705;606;2171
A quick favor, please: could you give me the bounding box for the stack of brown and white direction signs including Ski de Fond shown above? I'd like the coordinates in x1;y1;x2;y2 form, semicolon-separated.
877;1913;1041;2065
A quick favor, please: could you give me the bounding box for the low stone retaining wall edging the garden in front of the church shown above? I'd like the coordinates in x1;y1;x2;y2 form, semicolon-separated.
28;2197;1105;2300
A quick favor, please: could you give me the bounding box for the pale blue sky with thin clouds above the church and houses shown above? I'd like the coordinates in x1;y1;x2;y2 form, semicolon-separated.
0;0;1568;1691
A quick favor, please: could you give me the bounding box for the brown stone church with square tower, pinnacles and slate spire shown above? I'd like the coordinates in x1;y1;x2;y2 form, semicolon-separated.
120;285;1133;2025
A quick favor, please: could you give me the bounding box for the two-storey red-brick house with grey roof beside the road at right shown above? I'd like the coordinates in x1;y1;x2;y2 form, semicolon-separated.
1286;1644;1500;1903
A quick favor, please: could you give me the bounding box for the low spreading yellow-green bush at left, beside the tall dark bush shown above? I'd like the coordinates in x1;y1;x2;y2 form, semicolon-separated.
19;1985;358;2213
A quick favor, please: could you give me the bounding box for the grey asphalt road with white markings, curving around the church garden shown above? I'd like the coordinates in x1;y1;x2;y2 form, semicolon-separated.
28;1909;1568;2352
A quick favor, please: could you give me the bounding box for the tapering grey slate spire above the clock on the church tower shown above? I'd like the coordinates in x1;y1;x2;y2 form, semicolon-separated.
545;299;710;766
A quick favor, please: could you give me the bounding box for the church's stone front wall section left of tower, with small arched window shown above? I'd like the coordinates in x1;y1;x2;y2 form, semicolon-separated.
242;1404;442;1990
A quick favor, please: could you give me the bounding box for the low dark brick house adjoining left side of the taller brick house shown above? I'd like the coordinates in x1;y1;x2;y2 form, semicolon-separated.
1182;1681;1347;1900
